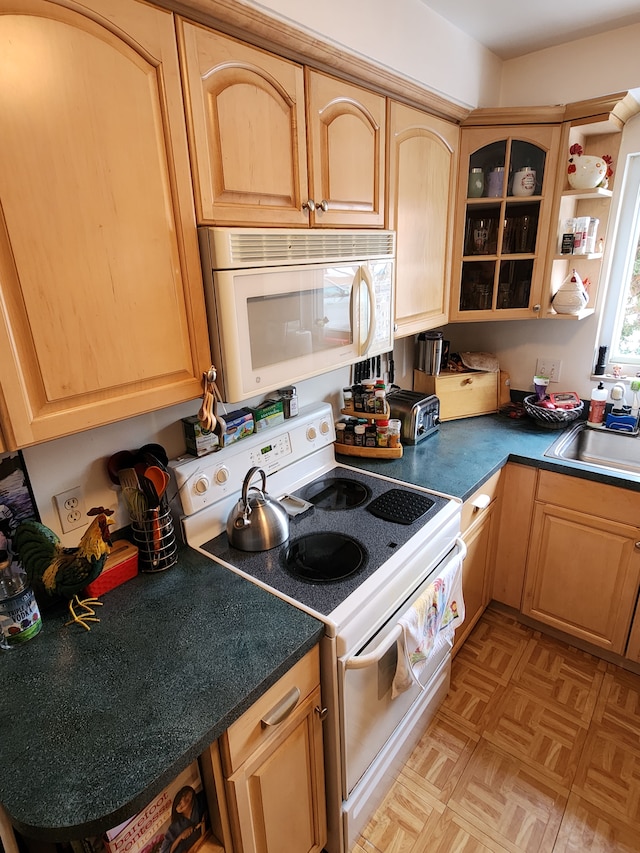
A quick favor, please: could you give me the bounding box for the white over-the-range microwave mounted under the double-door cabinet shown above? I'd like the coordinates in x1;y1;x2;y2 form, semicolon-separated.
198;227;395;403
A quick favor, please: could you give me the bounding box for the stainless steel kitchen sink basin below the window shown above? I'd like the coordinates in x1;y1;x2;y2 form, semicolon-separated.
544;421;640;475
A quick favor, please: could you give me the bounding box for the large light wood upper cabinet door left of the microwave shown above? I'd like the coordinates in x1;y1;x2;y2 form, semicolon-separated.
0;0;210;448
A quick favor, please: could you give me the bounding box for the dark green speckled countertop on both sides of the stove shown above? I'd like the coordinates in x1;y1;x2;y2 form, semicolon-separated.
5;414;640;841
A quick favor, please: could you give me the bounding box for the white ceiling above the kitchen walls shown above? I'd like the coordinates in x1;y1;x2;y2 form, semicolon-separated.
422;0;640;59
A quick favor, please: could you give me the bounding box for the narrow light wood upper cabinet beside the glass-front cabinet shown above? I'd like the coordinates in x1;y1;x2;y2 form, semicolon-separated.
387;101;460;337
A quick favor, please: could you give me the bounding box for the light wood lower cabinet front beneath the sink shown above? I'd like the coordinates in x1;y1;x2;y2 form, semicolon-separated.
522;471;640;655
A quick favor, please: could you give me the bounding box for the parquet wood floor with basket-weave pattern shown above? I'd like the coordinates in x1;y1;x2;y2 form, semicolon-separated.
352;607;640;853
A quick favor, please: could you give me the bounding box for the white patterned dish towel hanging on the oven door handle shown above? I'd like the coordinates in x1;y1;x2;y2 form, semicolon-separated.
391;537;467;699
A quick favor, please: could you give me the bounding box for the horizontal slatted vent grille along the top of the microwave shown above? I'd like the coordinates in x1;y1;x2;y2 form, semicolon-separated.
205;228;395;269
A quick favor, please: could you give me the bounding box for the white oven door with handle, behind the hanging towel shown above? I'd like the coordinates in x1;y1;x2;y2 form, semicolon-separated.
338;539;466;799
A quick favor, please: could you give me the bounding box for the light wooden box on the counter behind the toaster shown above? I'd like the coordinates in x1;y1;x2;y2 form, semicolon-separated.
413;370;500;421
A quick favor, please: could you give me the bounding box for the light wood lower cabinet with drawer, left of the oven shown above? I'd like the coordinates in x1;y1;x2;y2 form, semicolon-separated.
203;647;327;853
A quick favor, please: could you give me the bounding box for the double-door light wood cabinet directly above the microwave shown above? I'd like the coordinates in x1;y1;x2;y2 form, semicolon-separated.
178;19;386;227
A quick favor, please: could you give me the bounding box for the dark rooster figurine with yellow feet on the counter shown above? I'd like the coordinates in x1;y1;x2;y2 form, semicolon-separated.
13;507;113;631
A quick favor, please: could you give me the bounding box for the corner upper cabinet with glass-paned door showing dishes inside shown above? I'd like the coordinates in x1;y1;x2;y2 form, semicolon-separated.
450;124;560;322
